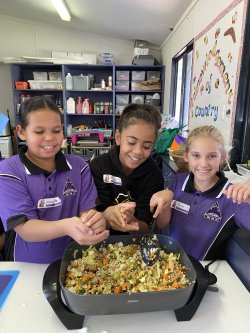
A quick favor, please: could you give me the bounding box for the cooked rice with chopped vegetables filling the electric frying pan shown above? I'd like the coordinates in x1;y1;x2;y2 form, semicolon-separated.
65;242;190;295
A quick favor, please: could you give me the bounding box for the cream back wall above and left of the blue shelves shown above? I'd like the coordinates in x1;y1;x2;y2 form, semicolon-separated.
0;15;161;123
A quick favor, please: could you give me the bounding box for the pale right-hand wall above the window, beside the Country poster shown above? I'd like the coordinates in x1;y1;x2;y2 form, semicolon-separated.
161;0;233;114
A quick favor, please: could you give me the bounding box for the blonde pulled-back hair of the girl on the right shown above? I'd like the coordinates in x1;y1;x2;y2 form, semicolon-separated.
185;126;227;156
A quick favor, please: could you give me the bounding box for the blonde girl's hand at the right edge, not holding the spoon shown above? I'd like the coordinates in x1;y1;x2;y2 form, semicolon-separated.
223;183;250;204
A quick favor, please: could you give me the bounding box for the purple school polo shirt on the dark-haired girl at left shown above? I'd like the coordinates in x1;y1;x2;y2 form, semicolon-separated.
0;150;97;263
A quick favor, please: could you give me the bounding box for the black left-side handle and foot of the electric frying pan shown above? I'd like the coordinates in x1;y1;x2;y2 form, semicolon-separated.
43;260;85;330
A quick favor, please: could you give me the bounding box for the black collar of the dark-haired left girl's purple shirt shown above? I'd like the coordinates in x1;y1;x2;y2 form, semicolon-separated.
18;146;70;176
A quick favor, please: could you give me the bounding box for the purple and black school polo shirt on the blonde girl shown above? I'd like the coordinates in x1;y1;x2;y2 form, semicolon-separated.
166;173;250;260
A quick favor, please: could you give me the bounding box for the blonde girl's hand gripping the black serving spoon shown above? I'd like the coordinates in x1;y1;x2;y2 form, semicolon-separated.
149;189;174;218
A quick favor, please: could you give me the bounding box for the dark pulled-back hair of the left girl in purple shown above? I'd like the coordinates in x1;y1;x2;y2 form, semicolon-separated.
19;96;61;128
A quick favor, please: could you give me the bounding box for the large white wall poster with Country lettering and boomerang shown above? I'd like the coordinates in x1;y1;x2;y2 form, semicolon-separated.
189;0;247;145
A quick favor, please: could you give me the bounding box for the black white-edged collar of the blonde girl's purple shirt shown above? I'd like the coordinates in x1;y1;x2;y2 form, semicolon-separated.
182;172;229;198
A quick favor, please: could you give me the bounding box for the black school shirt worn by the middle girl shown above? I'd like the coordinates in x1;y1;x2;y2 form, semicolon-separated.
90;146;164;234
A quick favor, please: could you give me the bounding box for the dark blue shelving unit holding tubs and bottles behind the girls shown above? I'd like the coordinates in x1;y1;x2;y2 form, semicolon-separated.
12;63;165;152
